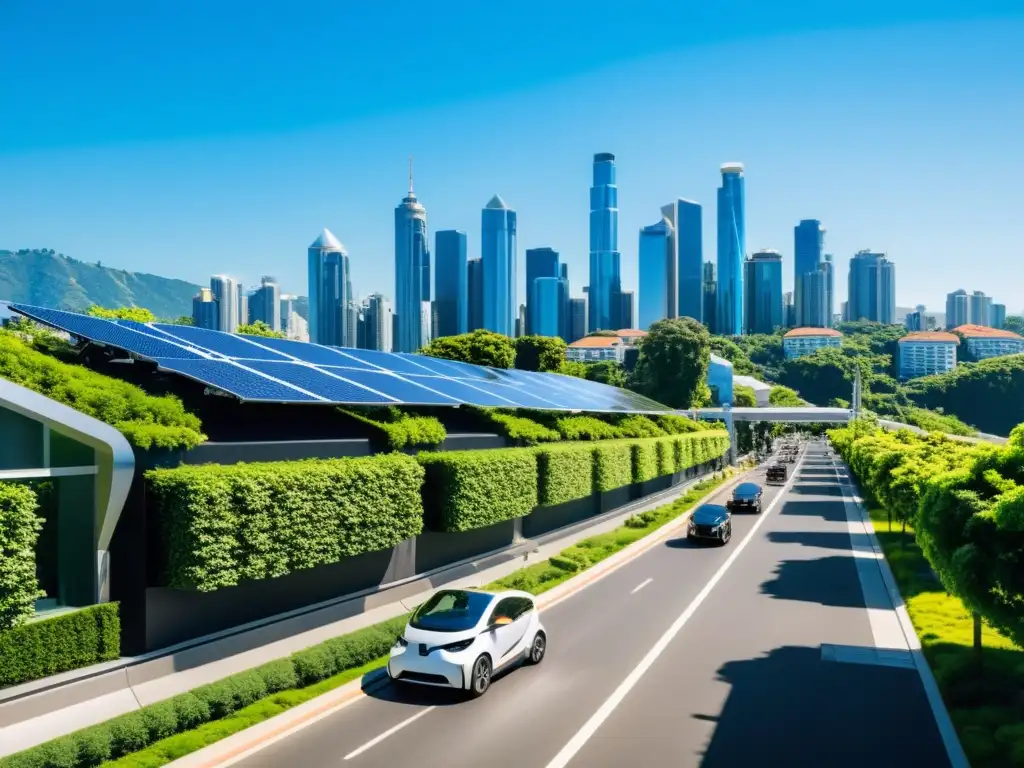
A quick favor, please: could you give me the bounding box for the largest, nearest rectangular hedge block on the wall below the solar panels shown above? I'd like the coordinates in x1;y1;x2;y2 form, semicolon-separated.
146;455;423;591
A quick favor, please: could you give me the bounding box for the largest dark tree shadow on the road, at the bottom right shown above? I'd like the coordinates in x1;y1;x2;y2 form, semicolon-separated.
691;646;949;768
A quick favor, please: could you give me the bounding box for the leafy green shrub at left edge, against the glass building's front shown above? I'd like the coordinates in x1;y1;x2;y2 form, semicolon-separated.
0;482;44;630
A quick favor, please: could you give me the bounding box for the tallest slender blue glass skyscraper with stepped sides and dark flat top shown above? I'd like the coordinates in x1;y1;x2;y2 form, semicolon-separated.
589;152;623;331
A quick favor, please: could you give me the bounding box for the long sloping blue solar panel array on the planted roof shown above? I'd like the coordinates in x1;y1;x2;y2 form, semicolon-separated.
10;304;670;414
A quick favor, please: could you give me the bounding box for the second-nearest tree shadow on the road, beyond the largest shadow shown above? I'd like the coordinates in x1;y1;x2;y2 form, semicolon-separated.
761;555;892;610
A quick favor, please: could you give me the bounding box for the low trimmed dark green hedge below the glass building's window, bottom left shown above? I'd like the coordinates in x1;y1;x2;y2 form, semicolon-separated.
0;603;121;688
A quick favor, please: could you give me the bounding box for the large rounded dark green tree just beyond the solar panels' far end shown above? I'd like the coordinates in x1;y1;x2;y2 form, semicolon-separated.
633;317;711;408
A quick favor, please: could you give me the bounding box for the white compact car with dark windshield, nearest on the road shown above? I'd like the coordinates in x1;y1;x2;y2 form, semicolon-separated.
387;590;548;698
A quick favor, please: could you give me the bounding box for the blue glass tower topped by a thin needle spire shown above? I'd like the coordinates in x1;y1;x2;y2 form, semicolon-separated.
394;165;430;352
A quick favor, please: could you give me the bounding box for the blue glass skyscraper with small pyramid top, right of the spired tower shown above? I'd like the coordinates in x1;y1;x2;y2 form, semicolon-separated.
480;195;518;336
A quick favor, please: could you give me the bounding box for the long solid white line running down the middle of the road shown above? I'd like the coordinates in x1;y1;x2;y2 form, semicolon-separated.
548;454;804;768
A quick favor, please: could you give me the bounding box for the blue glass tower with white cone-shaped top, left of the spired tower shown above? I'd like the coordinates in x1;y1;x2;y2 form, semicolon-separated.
308;229;352;347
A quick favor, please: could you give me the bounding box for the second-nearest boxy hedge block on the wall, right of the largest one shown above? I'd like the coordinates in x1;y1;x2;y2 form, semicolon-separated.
420;449;538;531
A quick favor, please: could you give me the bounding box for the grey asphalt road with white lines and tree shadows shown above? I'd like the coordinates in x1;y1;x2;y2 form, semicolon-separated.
241;444;949;768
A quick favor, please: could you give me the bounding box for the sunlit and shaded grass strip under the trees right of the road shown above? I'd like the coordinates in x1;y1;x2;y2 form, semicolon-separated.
870;509;1024;768
